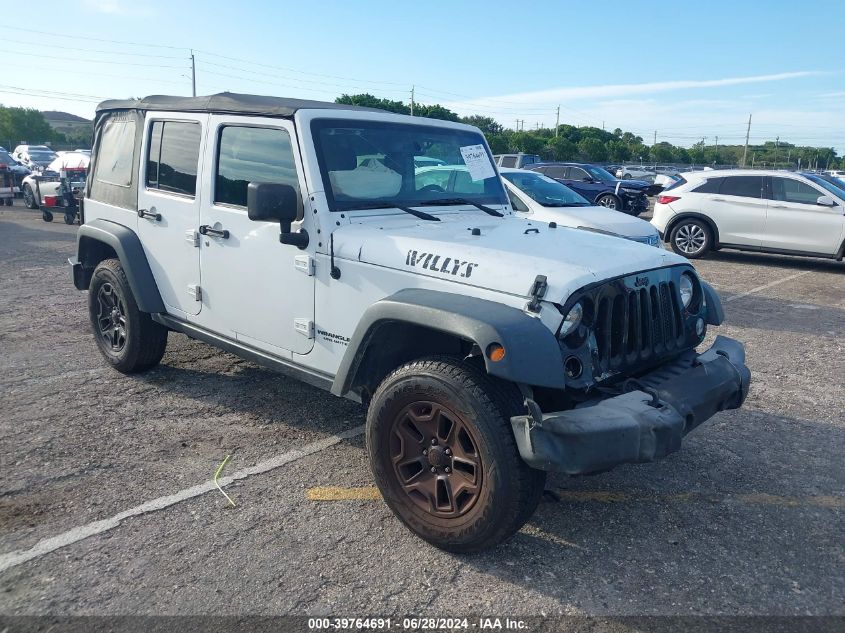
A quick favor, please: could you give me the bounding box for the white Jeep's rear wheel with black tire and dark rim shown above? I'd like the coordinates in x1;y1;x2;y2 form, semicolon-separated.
88;259;167;374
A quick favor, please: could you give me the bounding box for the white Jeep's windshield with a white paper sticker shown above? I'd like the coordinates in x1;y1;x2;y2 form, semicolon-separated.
311;119;507;211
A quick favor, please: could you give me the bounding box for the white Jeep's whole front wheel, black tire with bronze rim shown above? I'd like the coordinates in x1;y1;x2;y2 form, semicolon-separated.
367;357;546;553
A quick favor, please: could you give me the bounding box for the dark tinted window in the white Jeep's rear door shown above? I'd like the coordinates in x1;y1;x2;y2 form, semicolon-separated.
146;121;202;196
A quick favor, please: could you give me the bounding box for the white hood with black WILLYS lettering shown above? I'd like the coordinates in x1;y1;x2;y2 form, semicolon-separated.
334;211;687;302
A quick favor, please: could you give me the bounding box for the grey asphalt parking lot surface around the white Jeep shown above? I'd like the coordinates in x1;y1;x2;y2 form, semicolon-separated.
0;200;845;616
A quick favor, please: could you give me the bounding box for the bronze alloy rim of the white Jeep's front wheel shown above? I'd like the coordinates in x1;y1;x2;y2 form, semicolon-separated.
390;401;484;518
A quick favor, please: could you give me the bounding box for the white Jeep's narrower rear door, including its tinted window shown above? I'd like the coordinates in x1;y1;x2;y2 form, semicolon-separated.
138;113;208;318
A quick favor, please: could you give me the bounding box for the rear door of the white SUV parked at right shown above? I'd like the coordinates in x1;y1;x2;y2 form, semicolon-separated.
696;176;766;247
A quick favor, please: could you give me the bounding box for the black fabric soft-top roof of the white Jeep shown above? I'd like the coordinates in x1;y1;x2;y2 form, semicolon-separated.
97;92;384;119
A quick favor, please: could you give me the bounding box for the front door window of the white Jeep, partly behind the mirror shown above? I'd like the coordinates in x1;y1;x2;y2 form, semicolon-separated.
214;126;299;207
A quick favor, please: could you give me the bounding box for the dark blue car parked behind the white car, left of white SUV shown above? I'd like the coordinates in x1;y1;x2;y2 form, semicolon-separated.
525;163;660;215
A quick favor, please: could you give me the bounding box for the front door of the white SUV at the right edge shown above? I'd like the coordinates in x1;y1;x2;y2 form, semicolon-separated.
763;176;845;255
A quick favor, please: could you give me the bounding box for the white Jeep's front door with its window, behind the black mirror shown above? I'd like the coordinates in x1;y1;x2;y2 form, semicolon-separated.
196;115;317;357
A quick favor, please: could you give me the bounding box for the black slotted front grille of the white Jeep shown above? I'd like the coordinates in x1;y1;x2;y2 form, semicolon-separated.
594;281;687;375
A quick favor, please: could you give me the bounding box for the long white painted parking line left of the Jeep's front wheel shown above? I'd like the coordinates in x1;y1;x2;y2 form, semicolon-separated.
0;425;364;572
